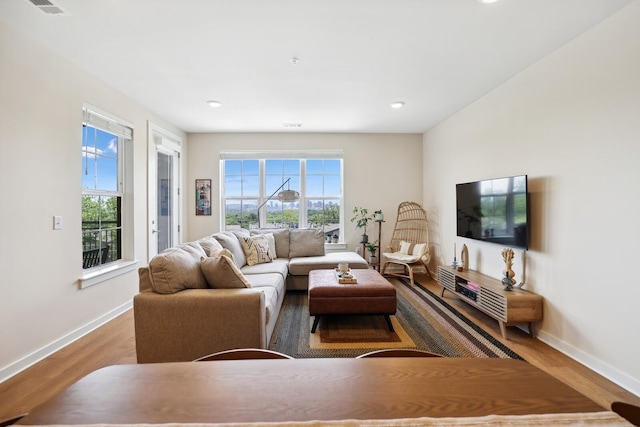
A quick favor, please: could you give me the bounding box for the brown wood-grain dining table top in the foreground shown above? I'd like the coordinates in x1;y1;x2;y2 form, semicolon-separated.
20;357;605;424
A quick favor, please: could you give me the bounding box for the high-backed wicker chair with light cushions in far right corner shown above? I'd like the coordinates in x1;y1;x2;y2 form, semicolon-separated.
380;202;431;285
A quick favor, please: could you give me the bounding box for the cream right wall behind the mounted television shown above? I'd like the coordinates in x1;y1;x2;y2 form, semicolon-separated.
424;1;640;395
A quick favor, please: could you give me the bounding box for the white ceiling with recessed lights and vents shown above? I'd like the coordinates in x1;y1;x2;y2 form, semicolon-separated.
0;0;631;133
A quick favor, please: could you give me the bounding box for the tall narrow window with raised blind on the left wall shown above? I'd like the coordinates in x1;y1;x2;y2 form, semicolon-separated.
82;108;133;269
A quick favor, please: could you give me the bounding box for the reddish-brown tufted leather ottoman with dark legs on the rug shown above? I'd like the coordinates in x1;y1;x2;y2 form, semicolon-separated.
309;269;396;333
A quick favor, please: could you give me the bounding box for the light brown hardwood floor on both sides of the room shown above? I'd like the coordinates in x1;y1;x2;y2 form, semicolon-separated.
0;276;640;419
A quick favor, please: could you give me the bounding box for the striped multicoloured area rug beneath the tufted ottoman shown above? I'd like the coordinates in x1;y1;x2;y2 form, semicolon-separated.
269;278;524;360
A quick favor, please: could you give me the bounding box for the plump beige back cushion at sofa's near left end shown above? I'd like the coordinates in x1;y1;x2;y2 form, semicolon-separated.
149;242;207;294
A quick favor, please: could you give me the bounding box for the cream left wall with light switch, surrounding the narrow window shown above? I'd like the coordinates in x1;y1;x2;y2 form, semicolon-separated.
0;22;185;381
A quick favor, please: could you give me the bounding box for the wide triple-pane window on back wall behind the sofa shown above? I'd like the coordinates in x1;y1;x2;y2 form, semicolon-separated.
221;153;343;240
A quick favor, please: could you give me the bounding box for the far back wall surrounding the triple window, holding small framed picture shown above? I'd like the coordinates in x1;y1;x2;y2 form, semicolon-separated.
185;133;422;250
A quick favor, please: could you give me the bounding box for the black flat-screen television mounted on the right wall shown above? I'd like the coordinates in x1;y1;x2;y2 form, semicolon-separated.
456;175;529;249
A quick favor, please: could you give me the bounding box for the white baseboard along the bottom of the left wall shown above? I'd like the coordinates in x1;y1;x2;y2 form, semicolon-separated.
0;301;133;383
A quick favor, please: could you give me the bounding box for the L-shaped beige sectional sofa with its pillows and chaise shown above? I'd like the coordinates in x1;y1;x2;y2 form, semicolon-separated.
133;229;368;363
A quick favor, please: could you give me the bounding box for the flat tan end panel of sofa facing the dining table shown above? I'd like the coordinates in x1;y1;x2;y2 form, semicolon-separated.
133;289;267;363
